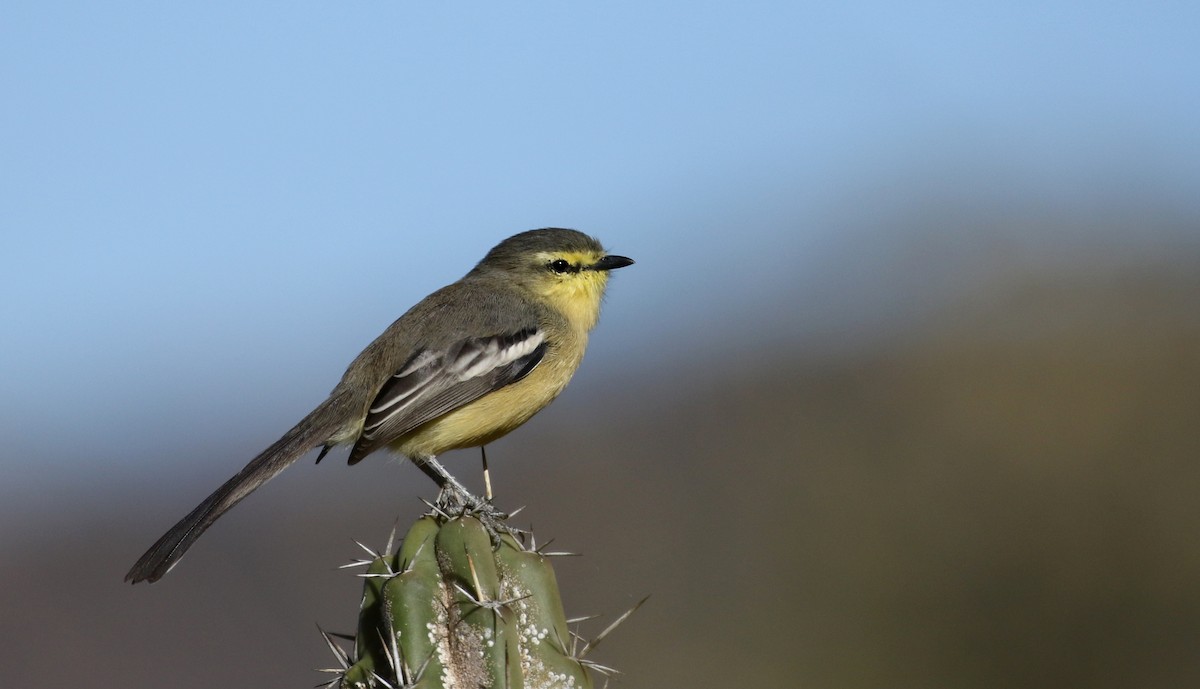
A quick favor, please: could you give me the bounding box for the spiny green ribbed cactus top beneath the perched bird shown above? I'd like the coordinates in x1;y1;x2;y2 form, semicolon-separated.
323;513;632;689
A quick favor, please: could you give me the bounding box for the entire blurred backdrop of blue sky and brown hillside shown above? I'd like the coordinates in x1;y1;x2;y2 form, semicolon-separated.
0;0;1200;689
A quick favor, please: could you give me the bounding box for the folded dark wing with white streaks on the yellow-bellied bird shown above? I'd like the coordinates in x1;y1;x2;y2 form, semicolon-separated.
348;326;546;465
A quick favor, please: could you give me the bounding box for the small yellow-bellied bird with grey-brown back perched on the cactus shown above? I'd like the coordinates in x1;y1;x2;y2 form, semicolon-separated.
125;228;634;583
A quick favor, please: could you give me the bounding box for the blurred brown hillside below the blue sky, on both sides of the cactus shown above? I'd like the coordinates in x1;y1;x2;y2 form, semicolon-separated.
0;256;1200;689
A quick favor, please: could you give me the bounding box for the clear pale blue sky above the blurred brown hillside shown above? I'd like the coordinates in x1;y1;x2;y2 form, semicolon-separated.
0;0;1200;496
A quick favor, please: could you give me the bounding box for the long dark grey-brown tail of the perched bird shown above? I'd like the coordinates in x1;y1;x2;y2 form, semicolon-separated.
125;390;353;583
